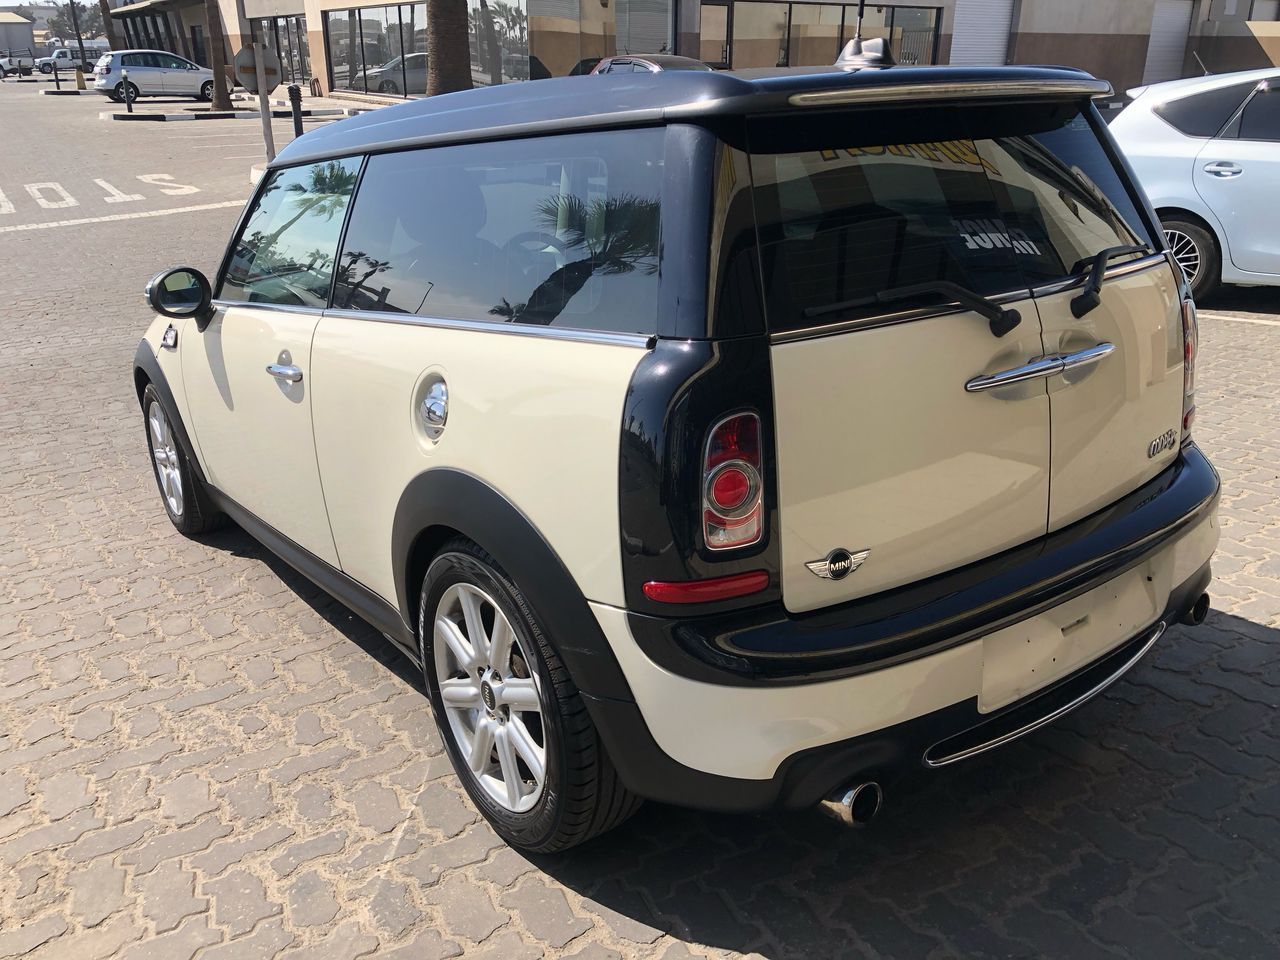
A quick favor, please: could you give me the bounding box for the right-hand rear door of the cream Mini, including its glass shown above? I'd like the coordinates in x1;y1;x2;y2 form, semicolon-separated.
982;108;1184;531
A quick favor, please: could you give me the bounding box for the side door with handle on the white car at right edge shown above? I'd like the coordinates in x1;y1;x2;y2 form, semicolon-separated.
1193;81;1280;274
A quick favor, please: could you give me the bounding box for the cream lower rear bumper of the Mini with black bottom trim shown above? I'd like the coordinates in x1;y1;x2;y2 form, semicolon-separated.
588;448;1219;810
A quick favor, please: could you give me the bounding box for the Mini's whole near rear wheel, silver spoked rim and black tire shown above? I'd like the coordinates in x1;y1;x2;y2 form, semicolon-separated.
419;540;640;852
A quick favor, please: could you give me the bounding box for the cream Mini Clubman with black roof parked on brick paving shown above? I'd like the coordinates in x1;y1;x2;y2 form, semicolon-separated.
134;68;1219;850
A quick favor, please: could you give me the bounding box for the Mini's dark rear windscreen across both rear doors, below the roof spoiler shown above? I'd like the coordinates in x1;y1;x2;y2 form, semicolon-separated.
748;104;1158;330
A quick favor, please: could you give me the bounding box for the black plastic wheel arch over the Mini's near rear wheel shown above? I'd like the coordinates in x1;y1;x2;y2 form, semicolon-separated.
392;467;632;700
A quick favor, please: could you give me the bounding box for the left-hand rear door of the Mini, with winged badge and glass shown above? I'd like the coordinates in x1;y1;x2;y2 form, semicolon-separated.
749;108;1050;612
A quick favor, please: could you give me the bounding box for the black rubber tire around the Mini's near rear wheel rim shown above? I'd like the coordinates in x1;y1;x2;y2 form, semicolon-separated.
419;539;643;852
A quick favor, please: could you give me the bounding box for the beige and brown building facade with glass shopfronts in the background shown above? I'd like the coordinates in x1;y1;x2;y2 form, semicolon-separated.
113;0;1280;97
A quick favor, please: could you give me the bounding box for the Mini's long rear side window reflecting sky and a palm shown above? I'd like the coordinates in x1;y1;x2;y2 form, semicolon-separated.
334;128;663;334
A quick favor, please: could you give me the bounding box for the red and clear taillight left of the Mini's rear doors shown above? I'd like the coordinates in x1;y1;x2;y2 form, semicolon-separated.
706;413;764;552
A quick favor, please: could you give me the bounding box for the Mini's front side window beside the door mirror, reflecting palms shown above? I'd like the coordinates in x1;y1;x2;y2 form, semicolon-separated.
218;157;360;307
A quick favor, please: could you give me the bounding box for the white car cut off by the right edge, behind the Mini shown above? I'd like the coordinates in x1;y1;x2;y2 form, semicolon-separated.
1111;68;1280;298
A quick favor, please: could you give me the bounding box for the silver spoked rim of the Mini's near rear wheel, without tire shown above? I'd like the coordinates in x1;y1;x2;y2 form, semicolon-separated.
433;584;547;813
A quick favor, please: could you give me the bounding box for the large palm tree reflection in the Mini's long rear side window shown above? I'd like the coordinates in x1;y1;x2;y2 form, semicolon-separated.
489;193;659;326
